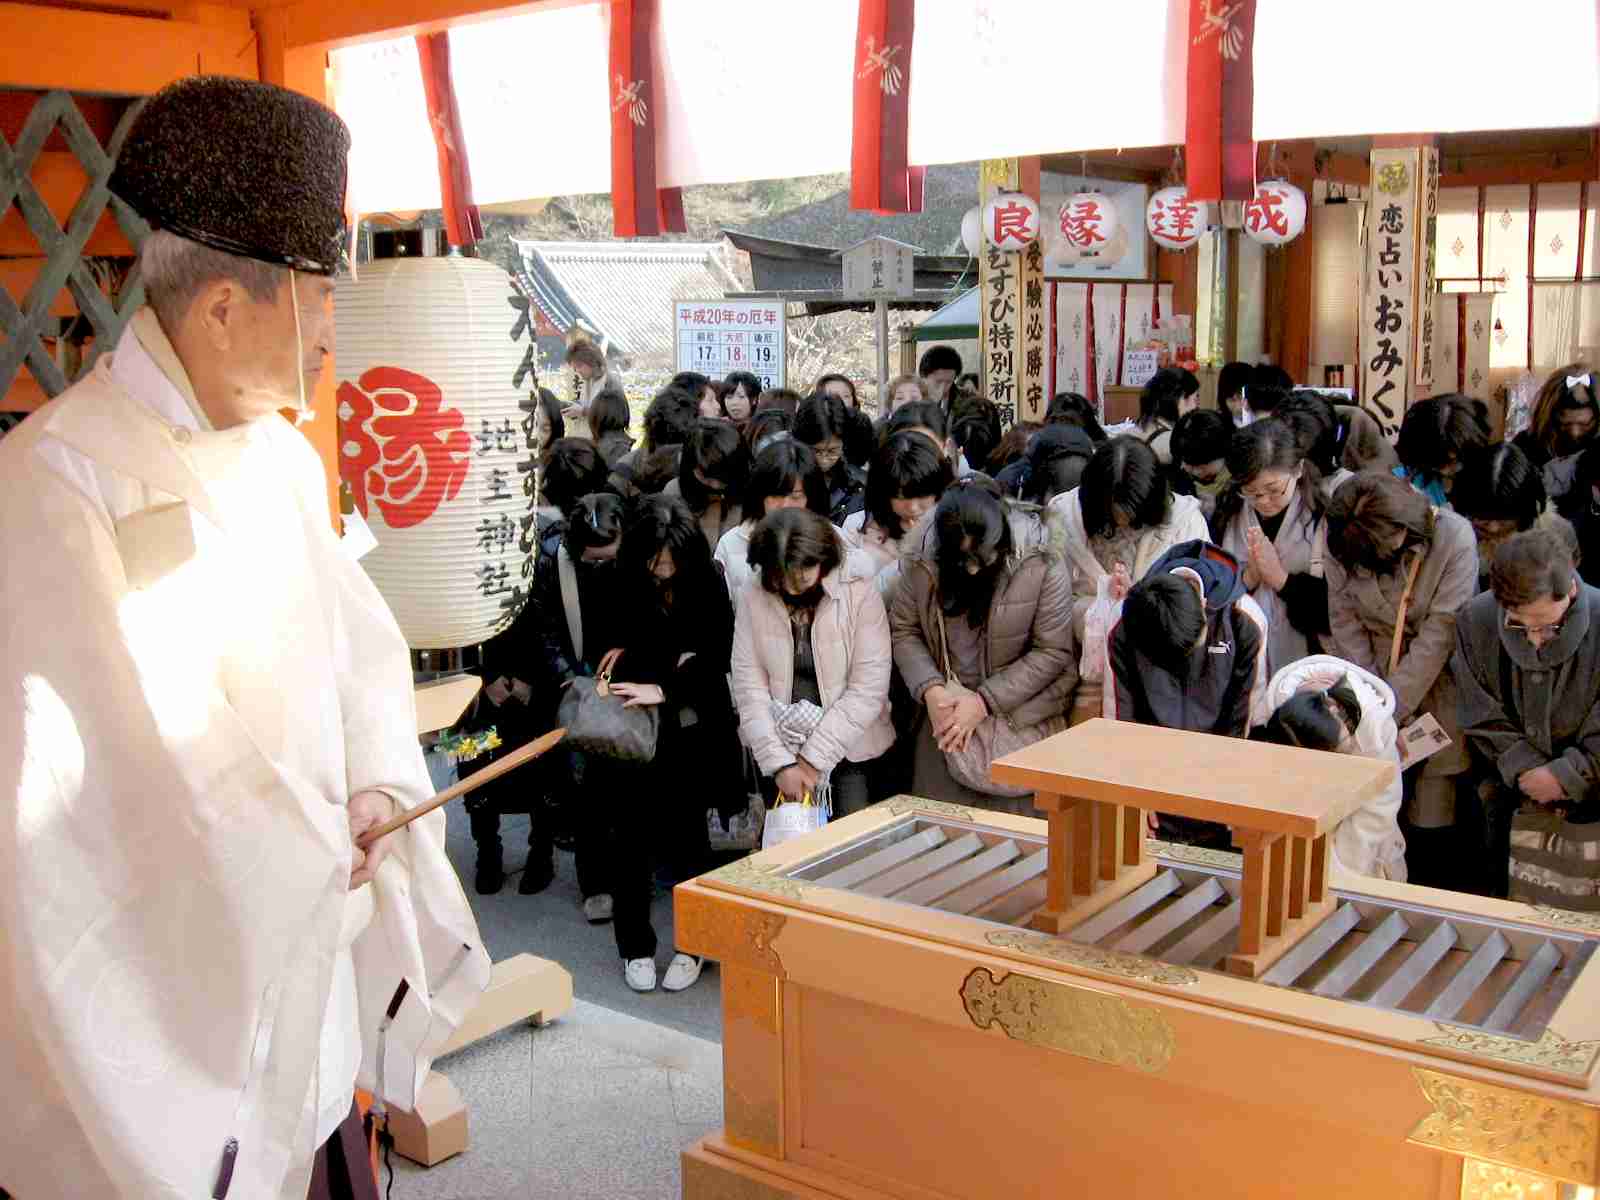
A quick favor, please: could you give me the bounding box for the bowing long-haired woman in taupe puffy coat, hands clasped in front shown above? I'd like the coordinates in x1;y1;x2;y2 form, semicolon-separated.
890;480;1077;811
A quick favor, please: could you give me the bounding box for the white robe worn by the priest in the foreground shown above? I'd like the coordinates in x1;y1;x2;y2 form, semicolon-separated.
0;314;490;1200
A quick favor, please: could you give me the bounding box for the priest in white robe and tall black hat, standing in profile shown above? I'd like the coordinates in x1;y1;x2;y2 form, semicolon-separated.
0;75;490;1200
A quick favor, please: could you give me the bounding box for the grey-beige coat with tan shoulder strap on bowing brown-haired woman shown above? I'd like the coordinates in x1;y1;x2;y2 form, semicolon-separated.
1326;512;1478;774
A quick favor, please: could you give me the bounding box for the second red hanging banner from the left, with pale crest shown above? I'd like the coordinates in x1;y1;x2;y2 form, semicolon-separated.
610;0;685;237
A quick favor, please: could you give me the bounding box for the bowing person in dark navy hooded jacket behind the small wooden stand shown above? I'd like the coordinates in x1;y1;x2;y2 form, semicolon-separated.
1106;541;1267;850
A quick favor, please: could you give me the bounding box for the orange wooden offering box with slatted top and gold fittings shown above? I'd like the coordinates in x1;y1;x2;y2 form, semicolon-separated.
675;739;1600;1200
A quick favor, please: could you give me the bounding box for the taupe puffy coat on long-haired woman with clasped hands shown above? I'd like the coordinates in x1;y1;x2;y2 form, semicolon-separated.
890;502;1078;730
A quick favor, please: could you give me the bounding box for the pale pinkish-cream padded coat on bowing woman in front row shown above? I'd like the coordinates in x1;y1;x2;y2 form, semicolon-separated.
733;568;894;774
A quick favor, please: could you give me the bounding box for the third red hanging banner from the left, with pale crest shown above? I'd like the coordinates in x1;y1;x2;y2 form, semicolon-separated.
850;0;923;213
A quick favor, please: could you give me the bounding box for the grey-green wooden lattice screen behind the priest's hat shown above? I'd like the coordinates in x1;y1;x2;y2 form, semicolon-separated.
0;91;149;403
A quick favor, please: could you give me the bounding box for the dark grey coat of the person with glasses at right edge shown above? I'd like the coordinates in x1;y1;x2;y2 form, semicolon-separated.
1453;584;1600;816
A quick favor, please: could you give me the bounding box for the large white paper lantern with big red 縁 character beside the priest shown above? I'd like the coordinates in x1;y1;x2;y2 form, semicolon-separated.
334;258;534;650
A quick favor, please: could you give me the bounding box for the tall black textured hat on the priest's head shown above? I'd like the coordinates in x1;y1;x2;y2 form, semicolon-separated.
110;75;350;275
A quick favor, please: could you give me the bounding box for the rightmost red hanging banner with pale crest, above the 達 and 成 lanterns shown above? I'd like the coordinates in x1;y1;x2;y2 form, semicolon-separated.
1184;0;1256;202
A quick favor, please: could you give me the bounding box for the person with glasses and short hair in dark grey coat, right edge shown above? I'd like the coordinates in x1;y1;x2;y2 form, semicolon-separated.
1453;530;1600;910
